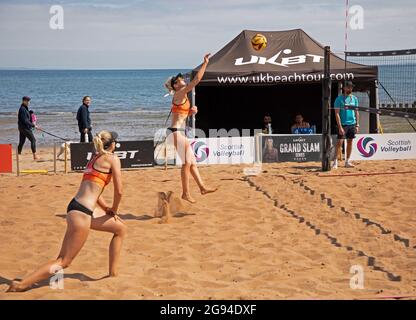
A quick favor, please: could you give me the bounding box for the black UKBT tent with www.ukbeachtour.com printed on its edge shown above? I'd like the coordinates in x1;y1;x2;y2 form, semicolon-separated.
192;29;378;134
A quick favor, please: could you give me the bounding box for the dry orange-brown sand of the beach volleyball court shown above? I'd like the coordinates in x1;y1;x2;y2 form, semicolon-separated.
0;149;416;299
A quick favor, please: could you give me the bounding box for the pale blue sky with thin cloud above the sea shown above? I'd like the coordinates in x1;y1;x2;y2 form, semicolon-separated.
0;0;416;69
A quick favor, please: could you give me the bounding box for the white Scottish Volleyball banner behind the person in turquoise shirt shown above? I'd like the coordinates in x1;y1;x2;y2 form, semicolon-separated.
351;133;416;160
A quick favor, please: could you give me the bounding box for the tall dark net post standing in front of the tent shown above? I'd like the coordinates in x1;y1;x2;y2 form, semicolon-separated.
322;46;332;171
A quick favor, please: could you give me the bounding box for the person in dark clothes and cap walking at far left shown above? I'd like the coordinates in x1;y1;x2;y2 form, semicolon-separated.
17;96;39;160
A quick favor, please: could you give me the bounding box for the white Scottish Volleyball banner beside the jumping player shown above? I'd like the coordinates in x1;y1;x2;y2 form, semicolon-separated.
176;137;255;165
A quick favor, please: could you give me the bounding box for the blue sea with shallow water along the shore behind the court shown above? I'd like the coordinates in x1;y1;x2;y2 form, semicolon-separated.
0;64;416;144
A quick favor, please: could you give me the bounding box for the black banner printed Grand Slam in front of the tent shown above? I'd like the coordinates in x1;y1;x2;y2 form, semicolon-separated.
262;134;336;163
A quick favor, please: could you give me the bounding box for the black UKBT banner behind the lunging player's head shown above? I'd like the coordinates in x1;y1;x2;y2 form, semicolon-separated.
70;140;154;171
